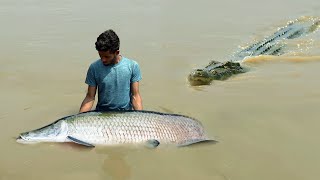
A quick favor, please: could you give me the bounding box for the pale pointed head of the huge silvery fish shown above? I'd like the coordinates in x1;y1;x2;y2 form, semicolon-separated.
17;120;68;143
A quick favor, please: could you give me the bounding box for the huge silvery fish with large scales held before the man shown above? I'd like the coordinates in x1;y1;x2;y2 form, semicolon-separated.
17;111;213;147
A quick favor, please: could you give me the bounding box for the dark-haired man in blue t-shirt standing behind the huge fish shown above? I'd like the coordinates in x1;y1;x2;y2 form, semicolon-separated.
79;29;142;112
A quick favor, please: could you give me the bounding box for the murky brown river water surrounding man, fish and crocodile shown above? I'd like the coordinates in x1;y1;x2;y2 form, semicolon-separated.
0;0;320;180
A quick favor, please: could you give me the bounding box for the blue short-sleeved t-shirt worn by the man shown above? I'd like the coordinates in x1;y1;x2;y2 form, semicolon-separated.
85;56;141;111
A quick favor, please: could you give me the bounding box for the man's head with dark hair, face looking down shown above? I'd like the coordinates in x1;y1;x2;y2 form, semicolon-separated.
95;29;120;65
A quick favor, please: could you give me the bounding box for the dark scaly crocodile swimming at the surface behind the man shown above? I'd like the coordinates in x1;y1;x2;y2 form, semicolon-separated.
188;17;320;86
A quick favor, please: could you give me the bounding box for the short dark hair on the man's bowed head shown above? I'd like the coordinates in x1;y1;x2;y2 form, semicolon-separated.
95;29;120;53
